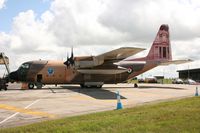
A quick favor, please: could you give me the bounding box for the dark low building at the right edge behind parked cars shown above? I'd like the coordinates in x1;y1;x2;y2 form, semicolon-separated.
177;68;200;82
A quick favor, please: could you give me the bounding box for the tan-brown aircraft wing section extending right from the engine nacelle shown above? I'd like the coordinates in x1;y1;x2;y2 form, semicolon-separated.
96;47;145;60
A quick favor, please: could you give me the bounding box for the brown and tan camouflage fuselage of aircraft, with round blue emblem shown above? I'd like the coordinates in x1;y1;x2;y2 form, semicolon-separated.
16;60;156;84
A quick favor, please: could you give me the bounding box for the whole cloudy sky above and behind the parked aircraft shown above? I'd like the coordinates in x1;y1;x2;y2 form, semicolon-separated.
0;0;200;77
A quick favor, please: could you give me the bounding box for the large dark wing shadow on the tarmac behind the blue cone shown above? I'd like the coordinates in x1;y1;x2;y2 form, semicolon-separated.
61;86;127;100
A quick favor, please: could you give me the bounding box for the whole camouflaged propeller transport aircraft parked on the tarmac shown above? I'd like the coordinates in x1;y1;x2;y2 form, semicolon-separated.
9;24;190;89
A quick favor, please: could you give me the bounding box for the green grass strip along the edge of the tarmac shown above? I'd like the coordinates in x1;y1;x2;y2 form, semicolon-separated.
0;97;200;133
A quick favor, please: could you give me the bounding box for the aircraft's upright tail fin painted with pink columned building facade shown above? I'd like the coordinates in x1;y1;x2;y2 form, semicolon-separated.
146;24;172;61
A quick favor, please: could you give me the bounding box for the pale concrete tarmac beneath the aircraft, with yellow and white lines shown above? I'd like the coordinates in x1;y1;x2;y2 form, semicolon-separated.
0;84;196;128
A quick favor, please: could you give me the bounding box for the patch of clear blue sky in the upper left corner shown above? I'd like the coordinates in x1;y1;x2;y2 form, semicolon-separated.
0;0;51;32
